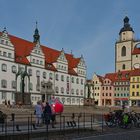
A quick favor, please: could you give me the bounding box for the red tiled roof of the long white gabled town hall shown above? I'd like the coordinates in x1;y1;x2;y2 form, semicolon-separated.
0;32;80;75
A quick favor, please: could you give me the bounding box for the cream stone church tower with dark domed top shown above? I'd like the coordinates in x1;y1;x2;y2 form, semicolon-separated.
115;16;135;72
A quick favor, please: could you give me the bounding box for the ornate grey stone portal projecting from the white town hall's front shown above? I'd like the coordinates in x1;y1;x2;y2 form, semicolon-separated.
41;81;55;101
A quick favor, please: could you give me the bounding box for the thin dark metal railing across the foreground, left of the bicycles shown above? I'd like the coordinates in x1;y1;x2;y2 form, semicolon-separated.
0;113;104;140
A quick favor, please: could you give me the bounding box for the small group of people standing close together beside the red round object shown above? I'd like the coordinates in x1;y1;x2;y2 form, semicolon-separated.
34;101;56;128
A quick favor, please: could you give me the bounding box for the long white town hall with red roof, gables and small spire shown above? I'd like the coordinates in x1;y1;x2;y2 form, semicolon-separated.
0;24;86;105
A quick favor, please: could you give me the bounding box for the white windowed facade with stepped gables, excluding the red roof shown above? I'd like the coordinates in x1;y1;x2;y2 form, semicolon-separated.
0;27;86;105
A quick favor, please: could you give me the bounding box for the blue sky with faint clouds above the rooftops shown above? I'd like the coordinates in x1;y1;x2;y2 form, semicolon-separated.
0;0;140;79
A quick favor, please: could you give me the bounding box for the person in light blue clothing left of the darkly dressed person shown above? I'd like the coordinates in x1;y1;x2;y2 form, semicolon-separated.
35;101;43;126
